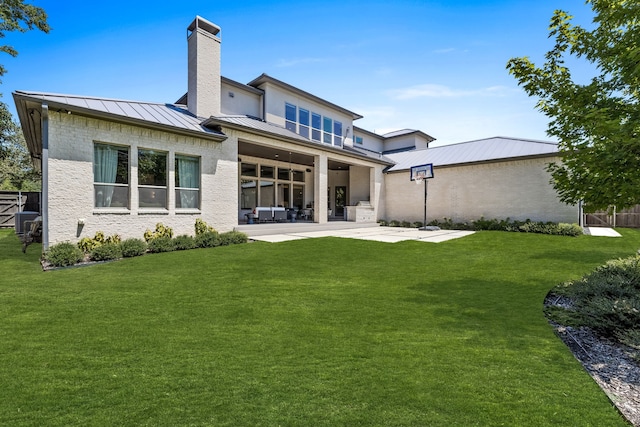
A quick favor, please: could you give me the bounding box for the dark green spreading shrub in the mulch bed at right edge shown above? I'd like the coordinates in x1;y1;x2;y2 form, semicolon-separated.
547;256;640;350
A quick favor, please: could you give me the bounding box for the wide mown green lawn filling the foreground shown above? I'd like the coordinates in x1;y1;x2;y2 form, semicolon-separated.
0;230;640;426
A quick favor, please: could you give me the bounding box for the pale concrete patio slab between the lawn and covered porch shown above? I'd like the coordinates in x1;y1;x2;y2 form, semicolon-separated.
237;222;474;243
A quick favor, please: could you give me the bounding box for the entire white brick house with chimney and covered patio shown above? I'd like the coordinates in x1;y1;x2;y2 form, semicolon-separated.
13;17;577;247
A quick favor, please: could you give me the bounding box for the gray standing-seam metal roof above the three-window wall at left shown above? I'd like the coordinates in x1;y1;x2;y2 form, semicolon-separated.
13;91;224;137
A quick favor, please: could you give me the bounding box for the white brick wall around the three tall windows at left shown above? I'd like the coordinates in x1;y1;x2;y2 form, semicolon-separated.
48;112;238;244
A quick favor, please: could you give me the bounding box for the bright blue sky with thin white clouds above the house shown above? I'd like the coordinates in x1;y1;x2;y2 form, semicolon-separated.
0;0;591;145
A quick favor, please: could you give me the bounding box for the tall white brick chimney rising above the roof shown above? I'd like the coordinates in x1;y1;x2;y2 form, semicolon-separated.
187;16;220;117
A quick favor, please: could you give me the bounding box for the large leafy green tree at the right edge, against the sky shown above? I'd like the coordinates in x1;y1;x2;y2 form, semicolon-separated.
507;0;640;211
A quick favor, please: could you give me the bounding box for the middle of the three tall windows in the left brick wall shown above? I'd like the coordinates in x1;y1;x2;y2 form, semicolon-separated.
138;150;167;209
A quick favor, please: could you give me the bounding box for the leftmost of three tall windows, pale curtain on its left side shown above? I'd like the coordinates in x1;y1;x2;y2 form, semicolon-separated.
93;144;129;208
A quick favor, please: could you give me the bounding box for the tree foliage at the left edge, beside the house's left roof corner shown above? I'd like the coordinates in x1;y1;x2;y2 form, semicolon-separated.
0;0;49;191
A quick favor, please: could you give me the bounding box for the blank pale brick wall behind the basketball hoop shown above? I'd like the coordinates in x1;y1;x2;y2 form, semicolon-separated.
383;158;578;223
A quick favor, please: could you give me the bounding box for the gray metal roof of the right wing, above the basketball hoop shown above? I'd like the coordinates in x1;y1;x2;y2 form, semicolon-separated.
386;136;558;172
